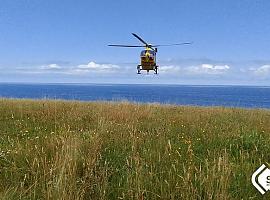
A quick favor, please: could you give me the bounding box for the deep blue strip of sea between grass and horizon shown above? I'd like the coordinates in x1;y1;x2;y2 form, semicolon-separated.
0;83;270;109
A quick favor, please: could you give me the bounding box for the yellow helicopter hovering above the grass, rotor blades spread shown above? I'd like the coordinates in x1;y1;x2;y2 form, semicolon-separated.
108;33;192;74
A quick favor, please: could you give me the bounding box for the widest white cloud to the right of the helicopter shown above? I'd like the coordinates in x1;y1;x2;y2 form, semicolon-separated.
185;64;230;74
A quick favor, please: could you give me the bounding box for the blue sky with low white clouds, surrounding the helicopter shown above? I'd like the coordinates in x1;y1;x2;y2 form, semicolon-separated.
0;0;270;85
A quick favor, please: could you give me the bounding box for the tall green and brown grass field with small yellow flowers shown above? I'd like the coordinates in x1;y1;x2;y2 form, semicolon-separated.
0;99;270;200
